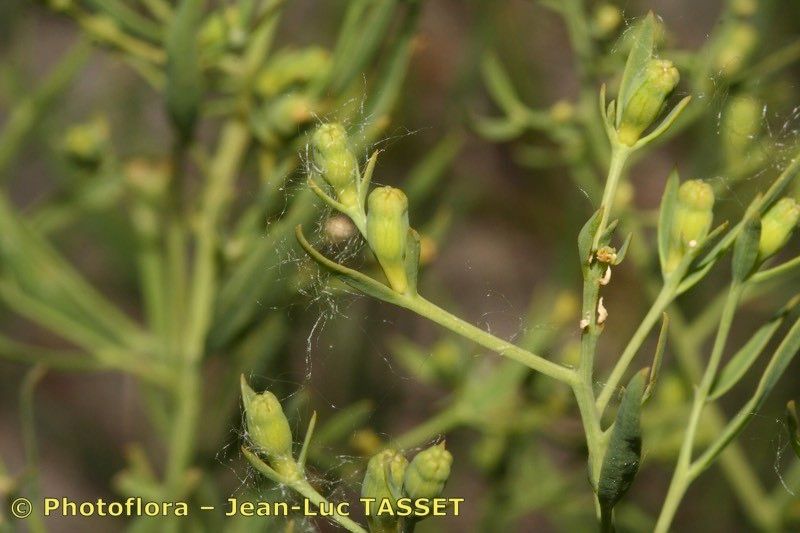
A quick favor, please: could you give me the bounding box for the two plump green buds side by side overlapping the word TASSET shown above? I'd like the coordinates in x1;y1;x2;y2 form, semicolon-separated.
361;442;453;532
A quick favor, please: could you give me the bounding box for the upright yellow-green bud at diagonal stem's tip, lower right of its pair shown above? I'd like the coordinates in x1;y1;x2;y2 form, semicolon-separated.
367;187;409;293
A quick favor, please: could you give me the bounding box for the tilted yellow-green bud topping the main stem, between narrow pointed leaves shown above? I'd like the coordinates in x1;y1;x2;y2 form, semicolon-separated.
618;59;680;146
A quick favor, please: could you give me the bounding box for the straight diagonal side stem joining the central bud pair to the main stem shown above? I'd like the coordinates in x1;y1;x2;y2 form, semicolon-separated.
403;296;577;384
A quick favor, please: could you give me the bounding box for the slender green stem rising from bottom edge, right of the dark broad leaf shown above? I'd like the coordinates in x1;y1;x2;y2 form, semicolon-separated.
655;282;742;533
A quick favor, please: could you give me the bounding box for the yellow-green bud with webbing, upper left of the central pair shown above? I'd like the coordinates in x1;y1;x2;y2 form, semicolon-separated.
311;124;358;207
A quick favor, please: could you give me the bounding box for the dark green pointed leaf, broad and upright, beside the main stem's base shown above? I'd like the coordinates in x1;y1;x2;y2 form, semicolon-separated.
597;368;650;516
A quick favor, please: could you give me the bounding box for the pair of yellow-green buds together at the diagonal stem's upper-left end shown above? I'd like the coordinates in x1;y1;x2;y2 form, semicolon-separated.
310;124;419;294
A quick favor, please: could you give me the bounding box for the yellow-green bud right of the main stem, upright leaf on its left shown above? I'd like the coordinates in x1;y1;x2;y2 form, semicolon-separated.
666;180;714;272
